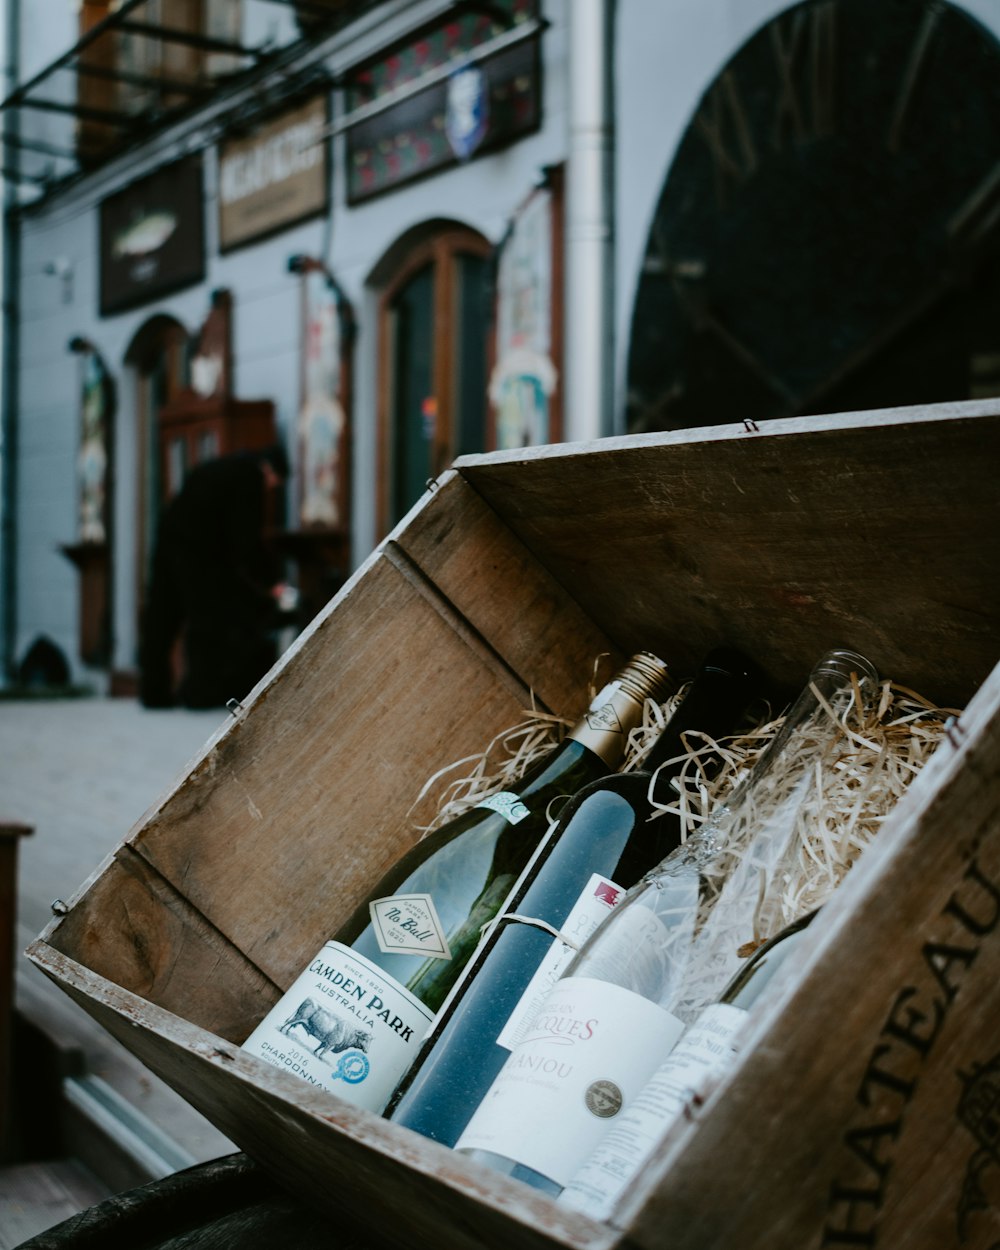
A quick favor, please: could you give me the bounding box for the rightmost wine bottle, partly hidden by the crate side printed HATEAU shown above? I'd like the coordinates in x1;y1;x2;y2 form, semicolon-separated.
559;911;818;1220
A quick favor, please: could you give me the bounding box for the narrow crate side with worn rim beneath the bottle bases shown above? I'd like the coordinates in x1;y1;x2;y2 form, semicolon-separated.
29;940;618;1250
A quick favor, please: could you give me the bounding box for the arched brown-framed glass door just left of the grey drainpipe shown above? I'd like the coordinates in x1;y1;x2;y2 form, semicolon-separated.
373;221;493;533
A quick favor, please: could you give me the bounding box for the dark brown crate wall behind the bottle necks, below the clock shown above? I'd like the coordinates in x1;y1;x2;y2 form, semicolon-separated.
456;399;1000;705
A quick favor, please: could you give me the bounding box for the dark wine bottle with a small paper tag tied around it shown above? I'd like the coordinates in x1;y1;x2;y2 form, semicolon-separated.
385;648;756;1146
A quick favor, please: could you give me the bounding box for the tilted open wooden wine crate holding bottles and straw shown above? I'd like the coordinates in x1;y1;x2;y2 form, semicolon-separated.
30;400;1000;1250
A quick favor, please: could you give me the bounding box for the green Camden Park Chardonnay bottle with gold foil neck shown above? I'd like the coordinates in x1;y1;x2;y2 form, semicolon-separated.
244;651;668;1111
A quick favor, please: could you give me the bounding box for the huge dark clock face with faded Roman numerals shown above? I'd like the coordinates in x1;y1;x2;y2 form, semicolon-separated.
628;0;1000;431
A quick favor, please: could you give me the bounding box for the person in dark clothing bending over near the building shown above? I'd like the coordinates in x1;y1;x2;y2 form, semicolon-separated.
140;446;289;708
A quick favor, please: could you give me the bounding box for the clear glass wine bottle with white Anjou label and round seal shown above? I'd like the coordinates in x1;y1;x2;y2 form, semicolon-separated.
456;650;878;1194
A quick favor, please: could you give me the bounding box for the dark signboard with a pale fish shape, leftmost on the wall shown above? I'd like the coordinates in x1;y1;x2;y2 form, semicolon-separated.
100;156;205;316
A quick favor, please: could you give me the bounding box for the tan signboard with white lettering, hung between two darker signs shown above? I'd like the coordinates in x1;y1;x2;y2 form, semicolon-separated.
219;96;330;251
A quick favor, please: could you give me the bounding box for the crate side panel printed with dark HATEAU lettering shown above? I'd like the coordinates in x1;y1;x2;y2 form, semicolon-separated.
620;670;1000;1250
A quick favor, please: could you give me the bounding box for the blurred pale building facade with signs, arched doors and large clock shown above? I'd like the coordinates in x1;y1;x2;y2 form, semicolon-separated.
0;0;1000;694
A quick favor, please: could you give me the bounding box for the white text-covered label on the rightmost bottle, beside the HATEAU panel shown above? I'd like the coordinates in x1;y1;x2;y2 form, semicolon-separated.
559;1003;746;1220
